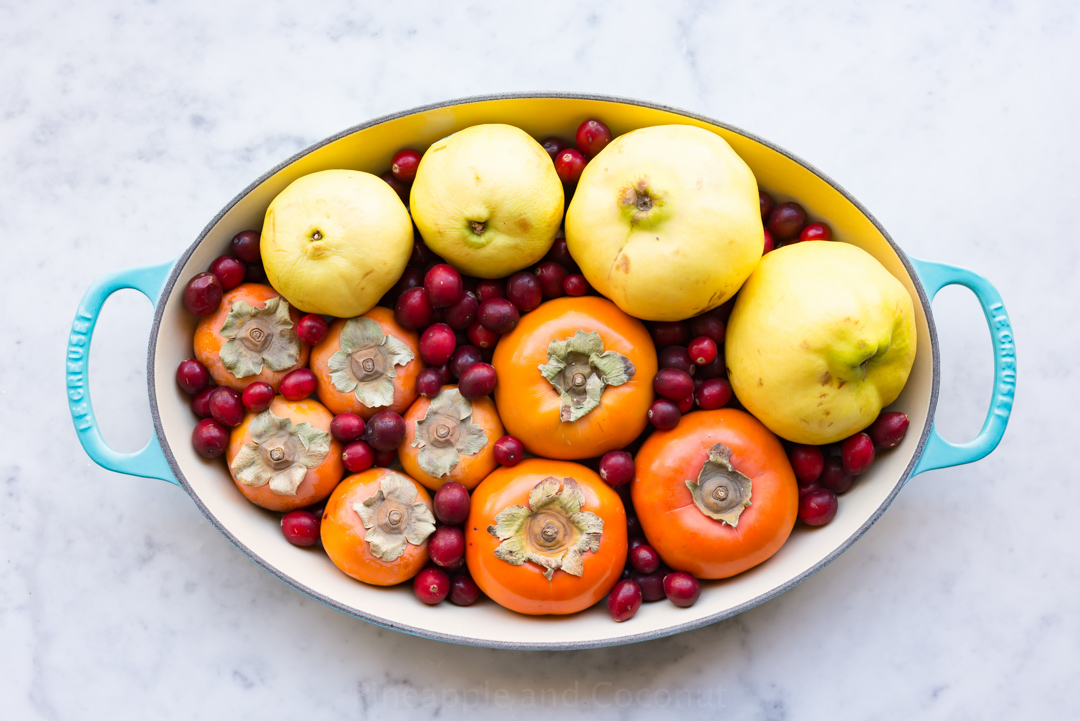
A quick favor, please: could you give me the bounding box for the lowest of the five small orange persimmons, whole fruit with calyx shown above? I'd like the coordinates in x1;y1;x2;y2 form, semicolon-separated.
320;468;435;586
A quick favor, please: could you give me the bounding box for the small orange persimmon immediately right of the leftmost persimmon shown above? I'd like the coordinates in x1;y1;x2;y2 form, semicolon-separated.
311;308;423;420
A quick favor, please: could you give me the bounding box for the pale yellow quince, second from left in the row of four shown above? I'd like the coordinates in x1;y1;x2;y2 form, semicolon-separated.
409;123;564;278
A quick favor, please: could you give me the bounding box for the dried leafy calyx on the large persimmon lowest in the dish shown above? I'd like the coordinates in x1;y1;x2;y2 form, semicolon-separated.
487;476;604;581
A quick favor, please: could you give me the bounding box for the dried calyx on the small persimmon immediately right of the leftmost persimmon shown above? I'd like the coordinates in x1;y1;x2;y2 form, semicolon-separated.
327;317;415;408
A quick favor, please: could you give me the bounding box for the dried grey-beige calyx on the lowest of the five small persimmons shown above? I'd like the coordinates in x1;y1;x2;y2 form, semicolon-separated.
352;471;435;563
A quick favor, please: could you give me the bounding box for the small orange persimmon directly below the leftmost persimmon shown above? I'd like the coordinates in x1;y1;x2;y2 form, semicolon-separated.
225;395;345;512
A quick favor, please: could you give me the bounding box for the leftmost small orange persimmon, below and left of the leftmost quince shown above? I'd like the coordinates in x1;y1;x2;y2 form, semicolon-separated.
193;283;311;391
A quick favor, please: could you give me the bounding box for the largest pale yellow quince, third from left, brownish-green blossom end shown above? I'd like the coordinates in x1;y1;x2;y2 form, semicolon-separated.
566;125;765;321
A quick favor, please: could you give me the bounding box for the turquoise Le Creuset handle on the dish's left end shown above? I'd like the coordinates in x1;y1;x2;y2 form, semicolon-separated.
66;261;179;486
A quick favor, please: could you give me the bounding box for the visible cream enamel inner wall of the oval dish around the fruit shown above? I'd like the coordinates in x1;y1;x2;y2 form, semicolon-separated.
151;97;935;648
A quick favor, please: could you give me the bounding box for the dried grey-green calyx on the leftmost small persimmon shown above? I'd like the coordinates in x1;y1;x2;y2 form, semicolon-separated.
218;297;300;378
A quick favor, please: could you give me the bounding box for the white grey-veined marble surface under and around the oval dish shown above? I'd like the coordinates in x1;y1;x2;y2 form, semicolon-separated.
0;0;1080;719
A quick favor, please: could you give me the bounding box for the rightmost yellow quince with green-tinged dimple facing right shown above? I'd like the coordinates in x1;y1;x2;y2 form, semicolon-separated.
725;241;916;446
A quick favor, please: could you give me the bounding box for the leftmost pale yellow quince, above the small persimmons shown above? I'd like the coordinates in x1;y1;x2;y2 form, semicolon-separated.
260;171;413;318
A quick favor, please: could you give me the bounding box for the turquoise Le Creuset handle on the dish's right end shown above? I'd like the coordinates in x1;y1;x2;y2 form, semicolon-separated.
912;258;1016;476
